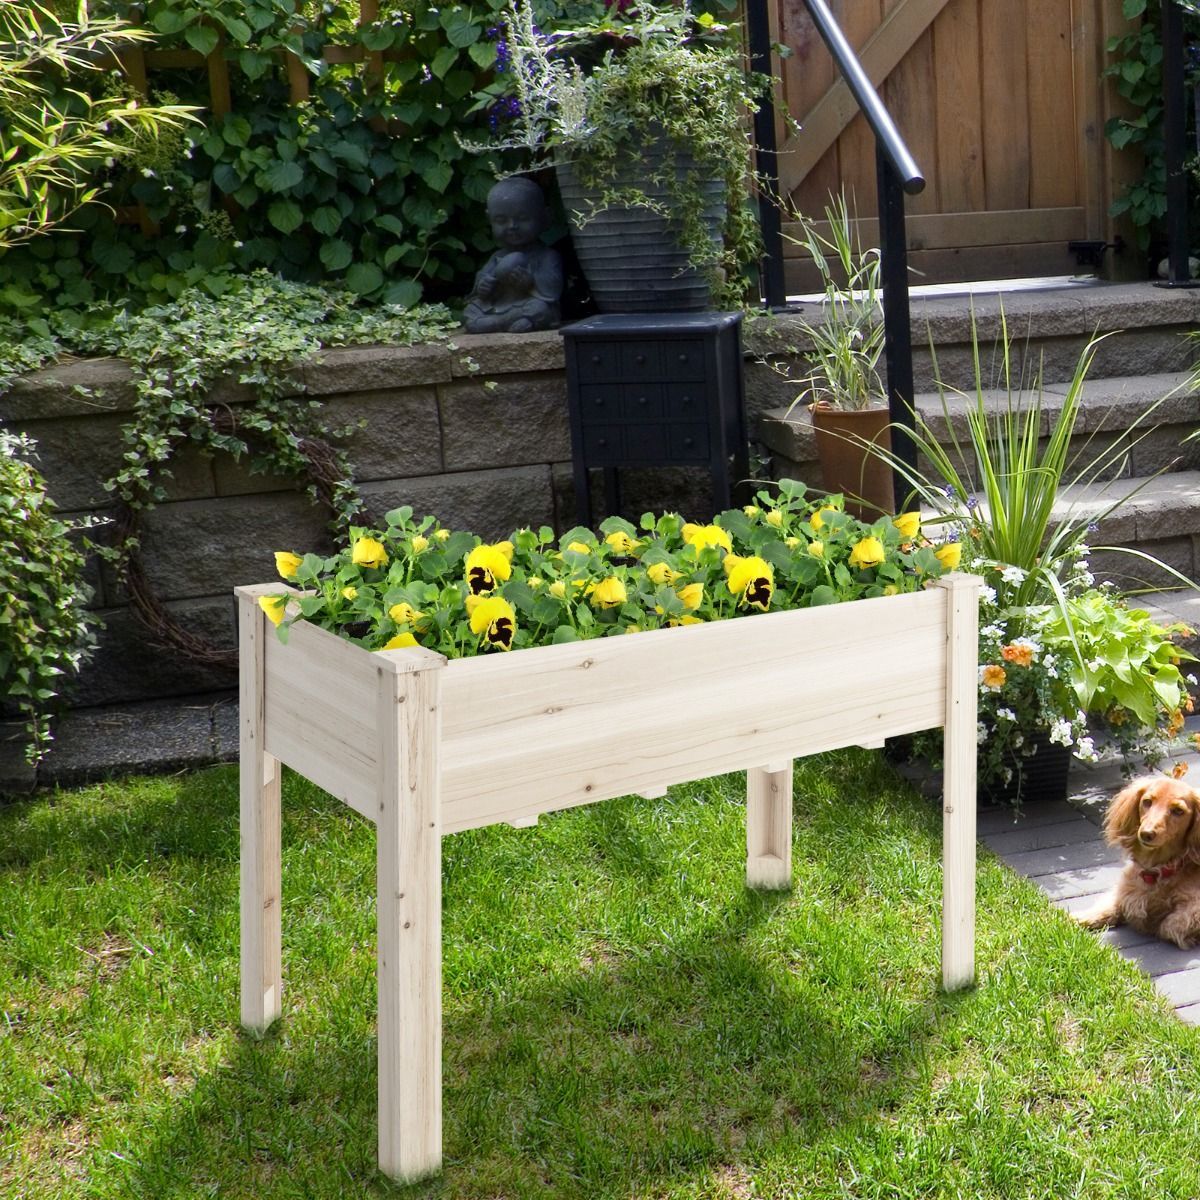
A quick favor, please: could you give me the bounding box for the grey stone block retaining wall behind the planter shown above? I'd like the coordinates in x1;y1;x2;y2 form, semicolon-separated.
0;334;791;707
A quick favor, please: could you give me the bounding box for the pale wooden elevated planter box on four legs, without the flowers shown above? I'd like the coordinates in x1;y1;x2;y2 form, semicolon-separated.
238;575;979;1180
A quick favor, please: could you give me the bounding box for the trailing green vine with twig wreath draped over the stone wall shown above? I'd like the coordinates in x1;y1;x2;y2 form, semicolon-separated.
0;271;454;667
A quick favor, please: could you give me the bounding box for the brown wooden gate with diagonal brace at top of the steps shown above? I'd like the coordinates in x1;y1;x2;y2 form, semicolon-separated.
774;0;1121;293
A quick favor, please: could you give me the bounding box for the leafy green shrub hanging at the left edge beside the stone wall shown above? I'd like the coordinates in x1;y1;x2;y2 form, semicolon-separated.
0;431;95;763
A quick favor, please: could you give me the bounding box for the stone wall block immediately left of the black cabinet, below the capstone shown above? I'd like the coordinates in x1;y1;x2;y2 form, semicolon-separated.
441;376;571;475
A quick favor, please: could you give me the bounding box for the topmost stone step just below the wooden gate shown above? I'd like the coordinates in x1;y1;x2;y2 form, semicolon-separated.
744;280;1200;415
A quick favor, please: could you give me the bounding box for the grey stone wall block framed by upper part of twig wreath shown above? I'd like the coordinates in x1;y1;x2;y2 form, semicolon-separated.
125;491;332;600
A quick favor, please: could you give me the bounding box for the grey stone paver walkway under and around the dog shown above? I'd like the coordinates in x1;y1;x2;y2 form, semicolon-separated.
978;754;1200;1025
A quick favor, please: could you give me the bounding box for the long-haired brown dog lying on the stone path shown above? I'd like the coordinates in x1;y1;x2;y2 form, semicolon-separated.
1078;776;1200;950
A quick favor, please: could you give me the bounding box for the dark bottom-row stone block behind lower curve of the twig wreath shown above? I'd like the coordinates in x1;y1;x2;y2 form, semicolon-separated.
67;597;238;707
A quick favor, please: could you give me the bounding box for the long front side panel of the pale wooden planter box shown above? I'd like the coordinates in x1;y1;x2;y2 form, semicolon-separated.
443;588;946;833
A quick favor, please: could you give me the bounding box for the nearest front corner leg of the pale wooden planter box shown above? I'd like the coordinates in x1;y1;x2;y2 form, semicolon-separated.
376;662;442;1181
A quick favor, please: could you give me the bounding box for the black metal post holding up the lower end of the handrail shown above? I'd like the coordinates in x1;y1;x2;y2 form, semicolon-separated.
875;140;917;512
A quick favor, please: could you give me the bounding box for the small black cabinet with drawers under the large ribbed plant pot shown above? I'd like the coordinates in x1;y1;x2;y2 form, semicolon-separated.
560;312;749;524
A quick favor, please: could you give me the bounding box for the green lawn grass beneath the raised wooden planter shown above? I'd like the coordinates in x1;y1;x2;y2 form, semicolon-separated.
0;751;1200;1200
